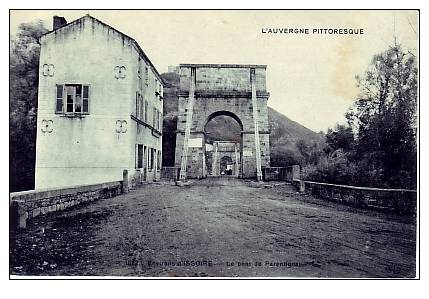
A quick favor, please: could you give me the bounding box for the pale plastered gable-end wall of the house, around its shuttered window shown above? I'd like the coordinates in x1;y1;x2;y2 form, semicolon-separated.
36;16;160;189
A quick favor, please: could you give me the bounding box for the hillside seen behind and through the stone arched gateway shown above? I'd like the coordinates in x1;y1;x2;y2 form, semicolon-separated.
161;73;324;166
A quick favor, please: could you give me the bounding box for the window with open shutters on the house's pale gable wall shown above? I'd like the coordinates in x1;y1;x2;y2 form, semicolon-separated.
55;84;89;113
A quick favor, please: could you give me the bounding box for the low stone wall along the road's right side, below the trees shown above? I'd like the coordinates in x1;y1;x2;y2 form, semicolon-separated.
293;180;417;215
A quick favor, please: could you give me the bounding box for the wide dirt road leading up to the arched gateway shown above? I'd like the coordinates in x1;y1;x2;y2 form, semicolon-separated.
10;179;416;277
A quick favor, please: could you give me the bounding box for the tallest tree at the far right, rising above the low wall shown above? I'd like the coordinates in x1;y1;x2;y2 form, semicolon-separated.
346;44;418;188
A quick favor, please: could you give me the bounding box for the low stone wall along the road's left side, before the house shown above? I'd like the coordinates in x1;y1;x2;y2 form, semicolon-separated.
9;181;122;228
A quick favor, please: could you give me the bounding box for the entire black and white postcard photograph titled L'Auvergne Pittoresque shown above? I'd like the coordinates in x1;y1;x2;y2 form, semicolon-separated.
8;9;420;280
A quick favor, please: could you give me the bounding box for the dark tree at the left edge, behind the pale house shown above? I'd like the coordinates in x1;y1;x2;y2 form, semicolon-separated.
9;21;48;192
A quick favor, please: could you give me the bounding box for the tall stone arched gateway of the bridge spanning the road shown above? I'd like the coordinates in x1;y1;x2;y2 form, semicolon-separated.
175;64;270;180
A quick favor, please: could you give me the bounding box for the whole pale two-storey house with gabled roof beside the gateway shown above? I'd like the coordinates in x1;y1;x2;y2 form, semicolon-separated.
36;15;163;189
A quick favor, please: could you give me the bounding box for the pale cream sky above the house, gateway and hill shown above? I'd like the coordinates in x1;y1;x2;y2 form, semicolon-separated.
10;10;419;132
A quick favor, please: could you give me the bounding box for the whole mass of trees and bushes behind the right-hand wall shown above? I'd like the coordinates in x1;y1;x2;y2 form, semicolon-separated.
299;44;418;189
